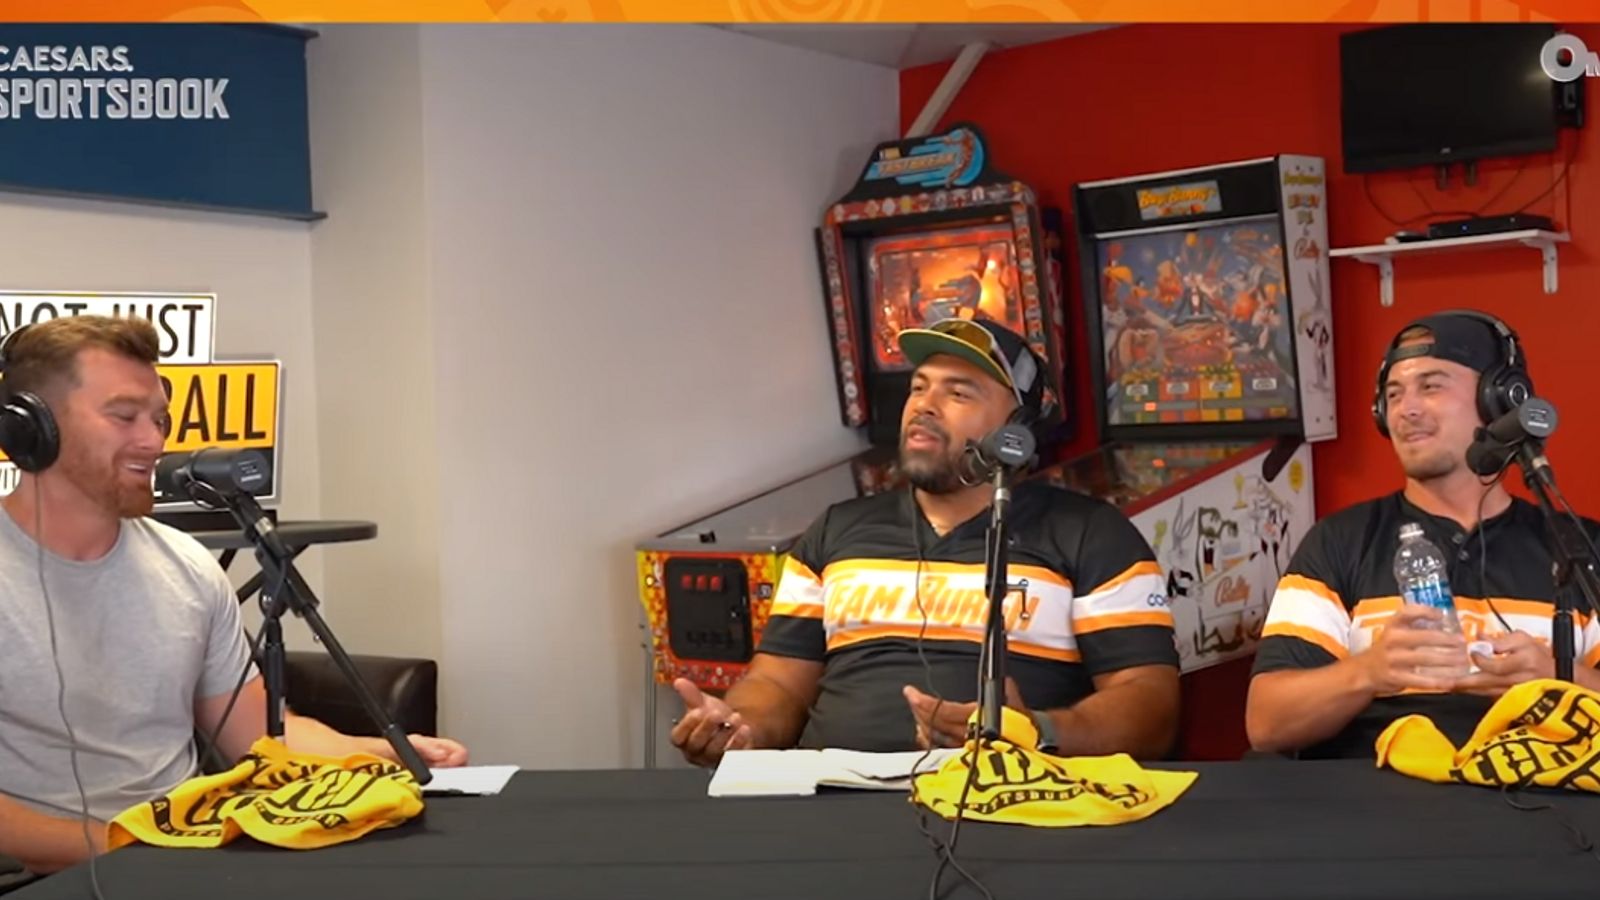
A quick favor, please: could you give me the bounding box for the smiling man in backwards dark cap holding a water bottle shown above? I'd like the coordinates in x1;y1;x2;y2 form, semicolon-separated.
1245;311;1600;757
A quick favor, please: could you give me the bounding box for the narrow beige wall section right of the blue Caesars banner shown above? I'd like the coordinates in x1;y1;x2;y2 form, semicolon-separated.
307;26;442;658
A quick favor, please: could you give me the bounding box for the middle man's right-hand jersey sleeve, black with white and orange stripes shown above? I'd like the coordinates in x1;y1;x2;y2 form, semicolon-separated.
1072;504;1178;676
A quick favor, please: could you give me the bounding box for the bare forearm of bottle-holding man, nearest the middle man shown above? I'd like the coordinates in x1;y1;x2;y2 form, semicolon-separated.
1245;657;1374;753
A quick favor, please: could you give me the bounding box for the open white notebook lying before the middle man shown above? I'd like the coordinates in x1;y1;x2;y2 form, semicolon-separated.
707;748;962;798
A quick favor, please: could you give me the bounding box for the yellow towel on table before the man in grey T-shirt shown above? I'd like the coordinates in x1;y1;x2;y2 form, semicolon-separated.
109;738;422;850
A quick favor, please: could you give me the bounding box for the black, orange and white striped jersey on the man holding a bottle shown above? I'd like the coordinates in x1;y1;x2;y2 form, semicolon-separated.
1254;492;1600;757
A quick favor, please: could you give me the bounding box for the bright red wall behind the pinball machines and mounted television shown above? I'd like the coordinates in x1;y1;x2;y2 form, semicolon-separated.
901;26;1600;757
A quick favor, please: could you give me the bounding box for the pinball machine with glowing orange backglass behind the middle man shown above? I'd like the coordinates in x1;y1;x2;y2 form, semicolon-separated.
637;125;1069;755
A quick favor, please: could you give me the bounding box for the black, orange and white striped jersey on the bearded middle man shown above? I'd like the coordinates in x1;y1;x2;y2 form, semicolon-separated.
760;482;1178;751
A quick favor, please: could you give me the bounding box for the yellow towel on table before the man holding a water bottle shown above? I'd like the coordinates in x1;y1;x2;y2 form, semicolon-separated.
1378;679;1600;793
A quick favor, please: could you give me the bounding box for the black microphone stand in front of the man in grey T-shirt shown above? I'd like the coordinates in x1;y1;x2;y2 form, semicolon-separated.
189;482;434;785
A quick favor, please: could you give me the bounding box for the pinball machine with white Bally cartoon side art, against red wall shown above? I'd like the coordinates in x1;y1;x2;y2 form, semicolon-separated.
1040;155;1336;673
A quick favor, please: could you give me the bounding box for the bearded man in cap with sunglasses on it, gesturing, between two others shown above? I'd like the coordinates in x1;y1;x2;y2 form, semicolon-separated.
672;319;1178;765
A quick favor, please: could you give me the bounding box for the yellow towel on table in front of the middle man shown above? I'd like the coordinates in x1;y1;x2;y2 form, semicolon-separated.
910;708;1198;828
